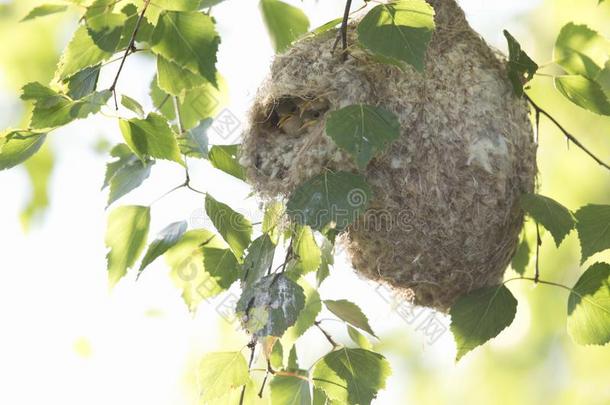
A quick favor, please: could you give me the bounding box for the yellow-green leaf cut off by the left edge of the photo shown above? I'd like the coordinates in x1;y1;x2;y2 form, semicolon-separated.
0;129;47;170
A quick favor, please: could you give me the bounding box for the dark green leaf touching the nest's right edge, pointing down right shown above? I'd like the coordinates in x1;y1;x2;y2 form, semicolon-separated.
521;194;575;247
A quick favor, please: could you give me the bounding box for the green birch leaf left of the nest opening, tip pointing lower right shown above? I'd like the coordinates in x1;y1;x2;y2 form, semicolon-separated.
119;113;184;165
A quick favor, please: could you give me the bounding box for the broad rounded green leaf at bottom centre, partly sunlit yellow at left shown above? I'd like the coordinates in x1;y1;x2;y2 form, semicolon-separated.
312;348;391;405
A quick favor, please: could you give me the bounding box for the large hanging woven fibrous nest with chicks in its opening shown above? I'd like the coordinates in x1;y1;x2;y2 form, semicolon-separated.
241;0;536;311
